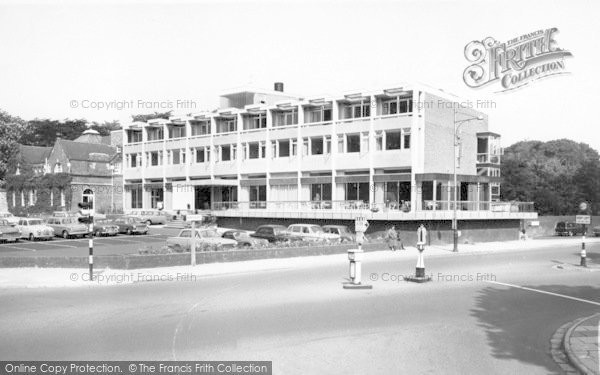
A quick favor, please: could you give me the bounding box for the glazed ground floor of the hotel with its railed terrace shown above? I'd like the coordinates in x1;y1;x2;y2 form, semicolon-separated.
124;174;537;220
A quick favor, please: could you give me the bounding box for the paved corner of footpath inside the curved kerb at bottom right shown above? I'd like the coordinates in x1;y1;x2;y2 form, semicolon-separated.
564;313;600;375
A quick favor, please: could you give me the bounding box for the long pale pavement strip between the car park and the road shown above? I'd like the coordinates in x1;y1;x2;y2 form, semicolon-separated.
0;238;600;288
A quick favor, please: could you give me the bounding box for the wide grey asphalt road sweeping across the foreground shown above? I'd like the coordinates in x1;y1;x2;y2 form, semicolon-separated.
0;243;600;374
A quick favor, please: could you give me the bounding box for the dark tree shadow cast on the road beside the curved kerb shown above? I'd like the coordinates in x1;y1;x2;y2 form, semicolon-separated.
471;285;600;374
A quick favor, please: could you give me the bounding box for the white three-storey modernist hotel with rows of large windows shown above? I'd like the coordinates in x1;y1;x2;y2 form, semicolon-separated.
123;83;536;236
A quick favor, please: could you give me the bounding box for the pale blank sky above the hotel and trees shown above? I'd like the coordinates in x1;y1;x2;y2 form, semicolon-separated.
0;0;600;150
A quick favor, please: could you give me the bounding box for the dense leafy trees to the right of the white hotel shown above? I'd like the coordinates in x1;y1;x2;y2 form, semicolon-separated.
501;139;600;215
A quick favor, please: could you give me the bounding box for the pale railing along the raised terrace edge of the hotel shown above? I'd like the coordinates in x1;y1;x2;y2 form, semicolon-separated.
212;200;535;213
